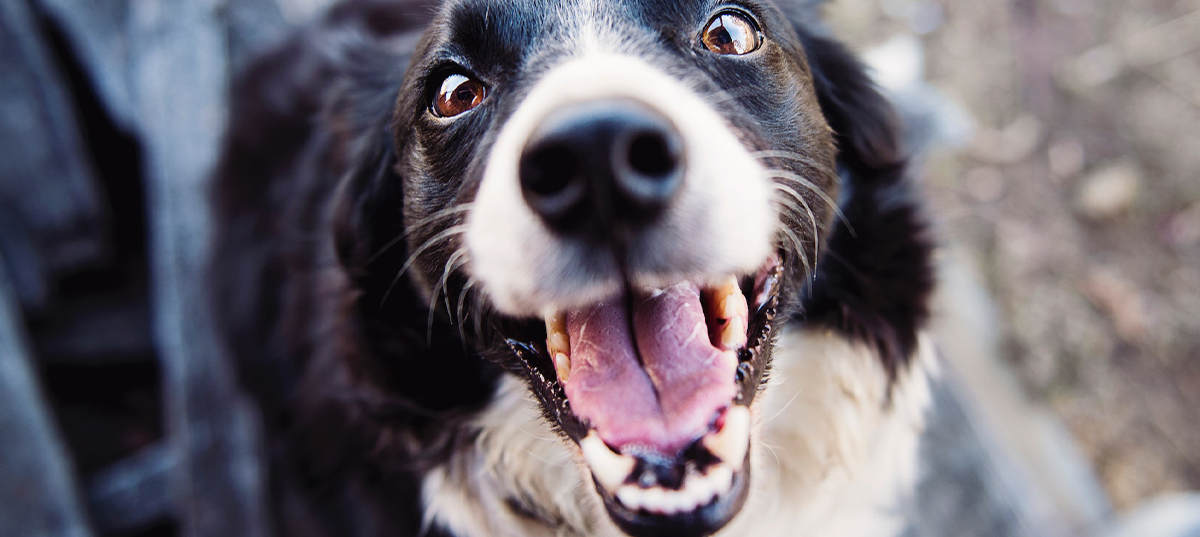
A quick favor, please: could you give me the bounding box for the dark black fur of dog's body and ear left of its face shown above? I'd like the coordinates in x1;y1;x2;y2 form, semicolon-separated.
212;2;499;537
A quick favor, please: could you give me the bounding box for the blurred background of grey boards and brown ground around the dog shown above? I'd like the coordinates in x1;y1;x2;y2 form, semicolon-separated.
0;0;1200;537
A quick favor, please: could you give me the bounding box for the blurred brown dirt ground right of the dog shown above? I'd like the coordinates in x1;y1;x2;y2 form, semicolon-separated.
828;0;1200;508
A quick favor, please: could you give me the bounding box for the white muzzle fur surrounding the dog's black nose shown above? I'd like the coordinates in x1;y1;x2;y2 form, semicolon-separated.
466;53;776;315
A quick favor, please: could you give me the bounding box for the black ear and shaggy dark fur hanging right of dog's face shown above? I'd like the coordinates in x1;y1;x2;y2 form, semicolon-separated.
798;29;935;378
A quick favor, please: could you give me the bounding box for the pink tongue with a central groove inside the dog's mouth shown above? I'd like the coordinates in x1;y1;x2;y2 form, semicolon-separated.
566;283;738;457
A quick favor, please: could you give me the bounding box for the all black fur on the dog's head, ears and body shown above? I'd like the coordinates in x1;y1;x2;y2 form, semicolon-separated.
212;0;932;537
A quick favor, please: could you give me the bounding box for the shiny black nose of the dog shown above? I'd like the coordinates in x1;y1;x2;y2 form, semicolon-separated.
520;101;683;235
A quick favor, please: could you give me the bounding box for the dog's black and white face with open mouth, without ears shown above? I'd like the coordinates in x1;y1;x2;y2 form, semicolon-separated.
395;0;838;535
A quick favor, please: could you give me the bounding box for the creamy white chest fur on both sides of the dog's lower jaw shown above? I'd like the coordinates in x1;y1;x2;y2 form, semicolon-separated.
425;332;937;537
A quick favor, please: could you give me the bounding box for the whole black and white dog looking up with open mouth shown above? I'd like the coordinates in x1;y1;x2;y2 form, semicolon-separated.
214;0;935;537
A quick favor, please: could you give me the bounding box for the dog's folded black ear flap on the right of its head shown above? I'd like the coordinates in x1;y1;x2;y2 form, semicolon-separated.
797;28;905;174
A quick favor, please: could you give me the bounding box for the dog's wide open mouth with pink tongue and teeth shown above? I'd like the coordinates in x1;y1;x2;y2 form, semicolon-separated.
510;255;782;536
